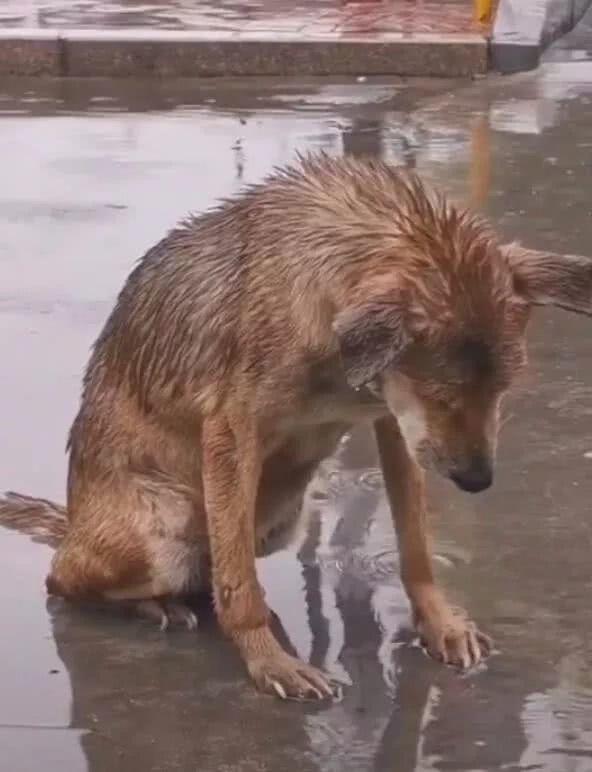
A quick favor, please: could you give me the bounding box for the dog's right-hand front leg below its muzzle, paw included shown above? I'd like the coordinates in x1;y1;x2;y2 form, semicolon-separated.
375;417;491;668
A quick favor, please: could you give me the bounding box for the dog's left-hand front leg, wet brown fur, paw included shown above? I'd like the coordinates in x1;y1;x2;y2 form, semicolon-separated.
203;416;334;699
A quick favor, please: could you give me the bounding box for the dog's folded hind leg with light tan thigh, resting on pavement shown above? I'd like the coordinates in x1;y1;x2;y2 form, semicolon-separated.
47;478;208;630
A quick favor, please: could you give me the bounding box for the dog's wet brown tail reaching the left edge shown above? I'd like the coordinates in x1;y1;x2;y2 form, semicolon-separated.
0;492;68;549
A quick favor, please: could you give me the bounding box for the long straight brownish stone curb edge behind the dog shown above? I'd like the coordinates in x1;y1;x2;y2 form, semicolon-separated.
0;29;488;77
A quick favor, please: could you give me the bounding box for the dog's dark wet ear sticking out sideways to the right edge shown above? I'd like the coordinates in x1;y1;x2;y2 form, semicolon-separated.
502;244;592;315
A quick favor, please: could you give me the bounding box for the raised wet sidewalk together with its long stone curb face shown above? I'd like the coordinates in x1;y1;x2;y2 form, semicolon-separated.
0;0;489;77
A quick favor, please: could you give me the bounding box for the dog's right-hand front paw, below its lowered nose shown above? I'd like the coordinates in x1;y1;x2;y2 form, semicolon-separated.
417;600;492;670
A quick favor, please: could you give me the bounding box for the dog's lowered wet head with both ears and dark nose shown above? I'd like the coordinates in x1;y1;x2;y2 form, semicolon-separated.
335;228;592;492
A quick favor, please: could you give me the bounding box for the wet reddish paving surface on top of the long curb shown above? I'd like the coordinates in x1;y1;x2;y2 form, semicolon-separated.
0;0;482;35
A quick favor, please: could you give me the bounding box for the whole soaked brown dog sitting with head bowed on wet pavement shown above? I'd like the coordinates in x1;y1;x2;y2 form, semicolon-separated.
0;156;592;697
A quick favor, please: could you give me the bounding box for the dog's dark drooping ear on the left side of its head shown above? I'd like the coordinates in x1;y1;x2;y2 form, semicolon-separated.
333;295;411;389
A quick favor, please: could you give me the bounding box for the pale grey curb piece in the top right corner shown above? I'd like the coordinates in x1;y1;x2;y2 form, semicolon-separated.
491;0;592;74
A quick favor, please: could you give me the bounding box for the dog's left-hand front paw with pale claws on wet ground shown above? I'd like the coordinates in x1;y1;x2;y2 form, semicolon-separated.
247;651;341;700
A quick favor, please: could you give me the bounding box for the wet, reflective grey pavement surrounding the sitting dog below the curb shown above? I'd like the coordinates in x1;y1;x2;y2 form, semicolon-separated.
0;16;592;772
